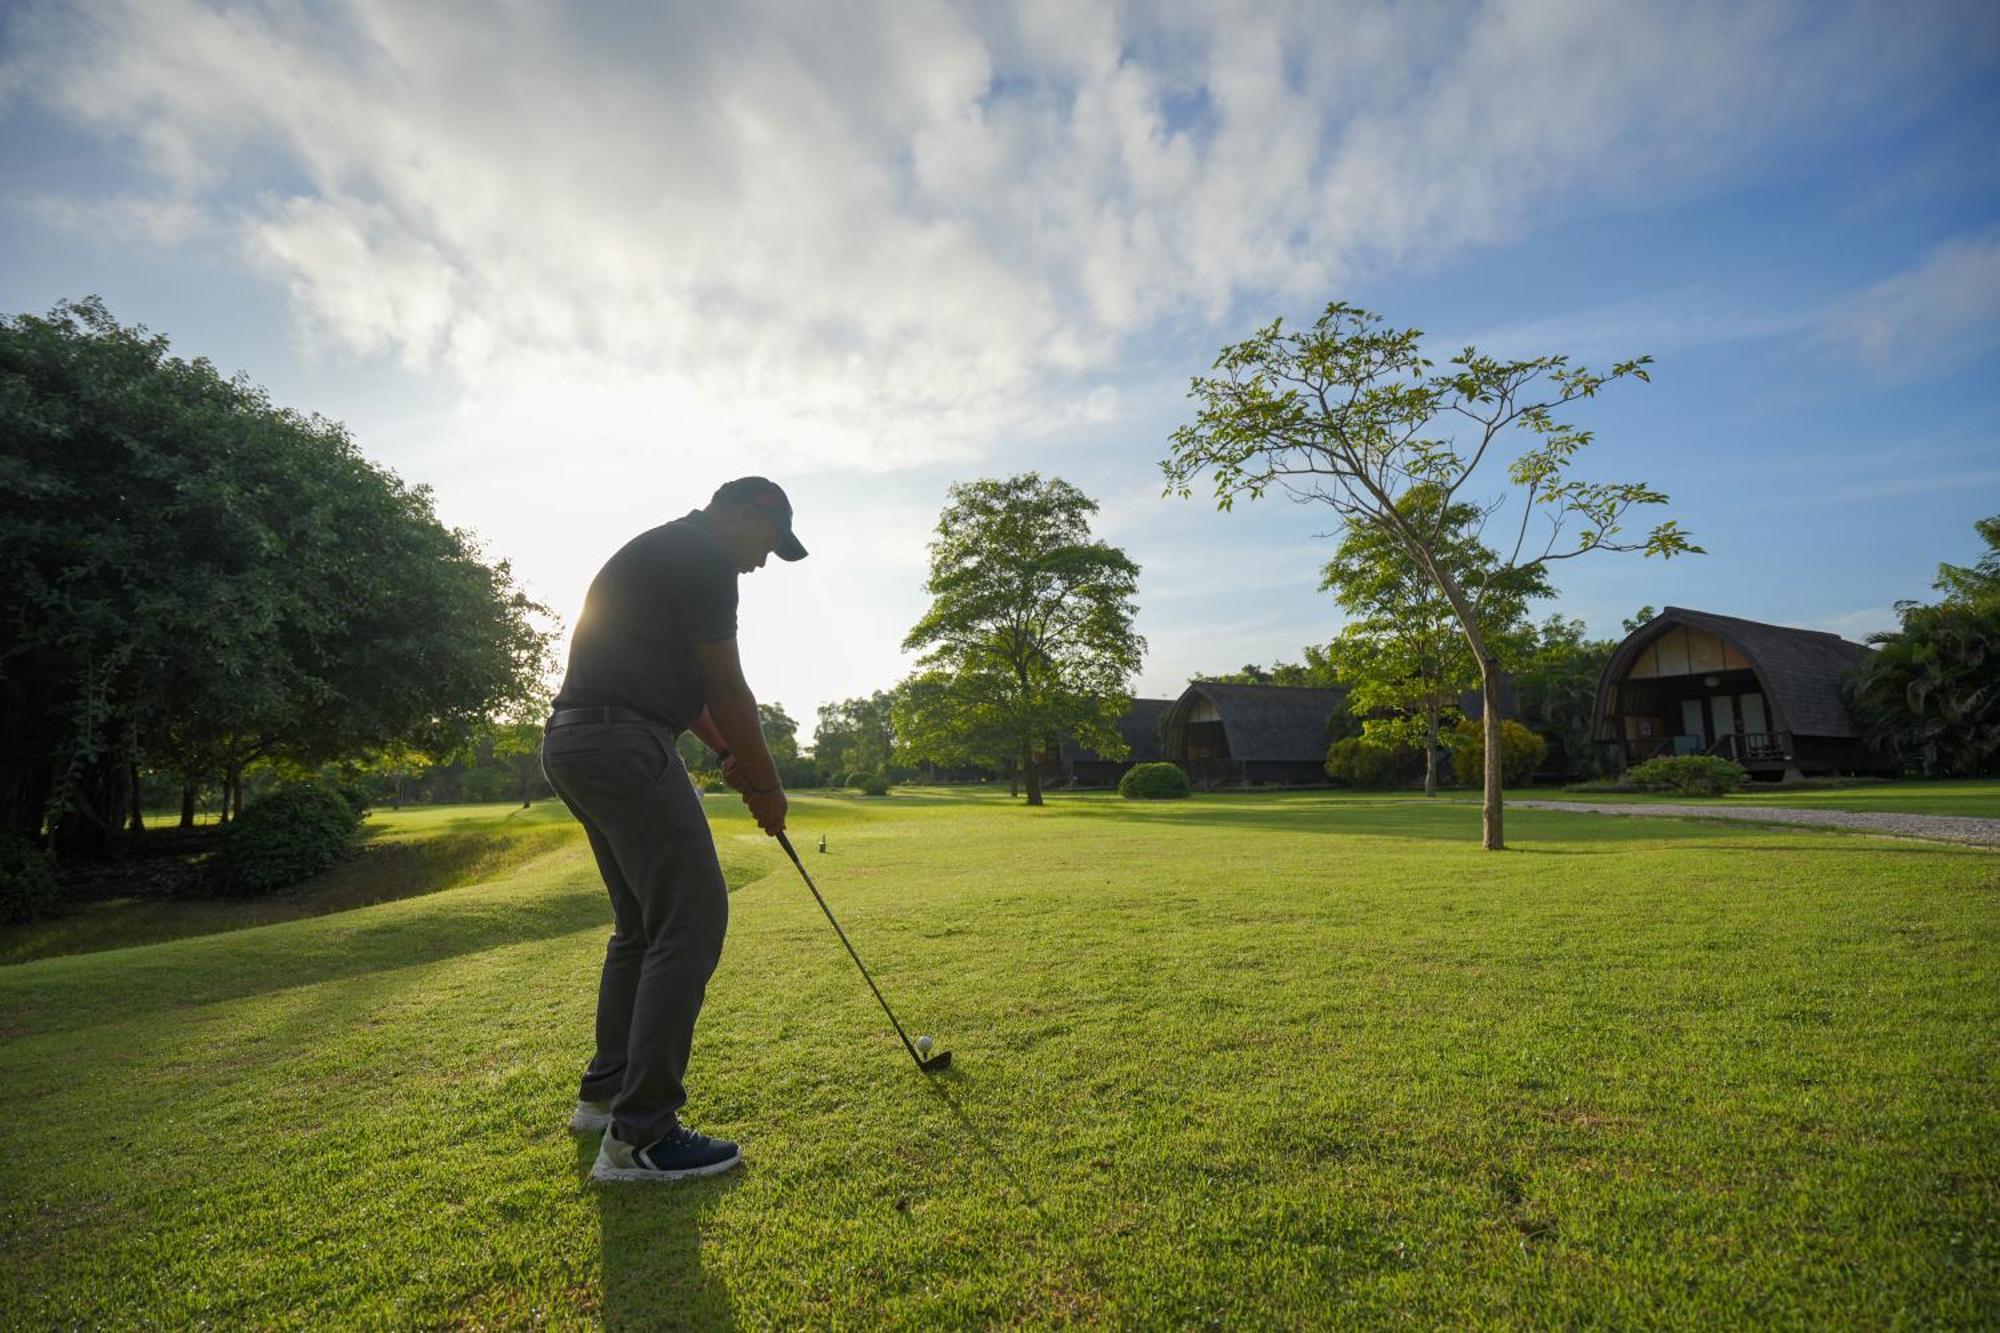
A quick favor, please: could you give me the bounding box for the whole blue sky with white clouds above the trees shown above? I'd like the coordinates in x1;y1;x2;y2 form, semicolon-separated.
0;0;2000;731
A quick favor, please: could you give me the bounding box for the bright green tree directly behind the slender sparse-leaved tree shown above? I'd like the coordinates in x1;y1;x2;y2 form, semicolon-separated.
1320;484;1552;797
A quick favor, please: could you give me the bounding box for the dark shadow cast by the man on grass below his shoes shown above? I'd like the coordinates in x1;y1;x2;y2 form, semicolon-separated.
576;1135;748;1329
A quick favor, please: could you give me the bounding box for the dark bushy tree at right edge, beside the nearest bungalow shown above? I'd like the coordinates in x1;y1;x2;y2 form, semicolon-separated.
1848;514;2000;777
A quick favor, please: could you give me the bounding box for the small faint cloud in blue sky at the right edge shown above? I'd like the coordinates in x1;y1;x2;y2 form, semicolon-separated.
1822;232;2000;378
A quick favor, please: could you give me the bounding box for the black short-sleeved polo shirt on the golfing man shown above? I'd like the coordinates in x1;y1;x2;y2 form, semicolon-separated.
556;508;736;731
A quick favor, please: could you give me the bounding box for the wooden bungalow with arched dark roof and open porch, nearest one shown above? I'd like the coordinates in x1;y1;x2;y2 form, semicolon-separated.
1596;606;1872;779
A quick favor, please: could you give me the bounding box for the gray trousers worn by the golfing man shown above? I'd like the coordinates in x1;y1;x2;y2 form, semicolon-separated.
542;723;730;1145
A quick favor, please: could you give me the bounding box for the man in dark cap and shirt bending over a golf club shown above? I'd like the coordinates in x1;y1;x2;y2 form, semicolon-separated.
542;476;806;1181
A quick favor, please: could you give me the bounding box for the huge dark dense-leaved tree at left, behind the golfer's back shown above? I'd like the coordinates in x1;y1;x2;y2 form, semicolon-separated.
0;300;548;857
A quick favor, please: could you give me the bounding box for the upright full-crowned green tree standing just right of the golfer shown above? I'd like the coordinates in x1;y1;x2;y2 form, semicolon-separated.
902;472;1146;805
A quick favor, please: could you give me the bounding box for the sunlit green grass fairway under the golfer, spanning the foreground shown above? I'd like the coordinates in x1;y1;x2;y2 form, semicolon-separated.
0;791;2000;1329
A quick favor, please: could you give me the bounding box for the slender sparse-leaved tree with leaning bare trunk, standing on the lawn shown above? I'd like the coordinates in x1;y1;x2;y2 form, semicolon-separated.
1162;302;1700;849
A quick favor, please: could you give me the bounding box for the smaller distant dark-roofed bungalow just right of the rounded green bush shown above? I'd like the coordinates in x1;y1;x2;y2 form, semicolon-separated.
1164;681;1346;787
